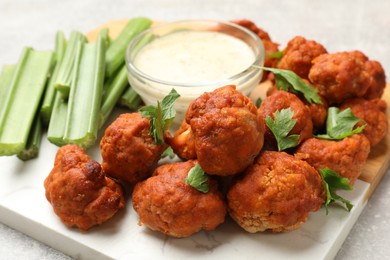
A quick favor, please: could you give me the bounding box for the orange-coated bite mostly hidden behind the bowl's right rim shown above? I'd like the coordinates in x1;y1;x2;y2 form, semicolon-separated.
232;19;279;81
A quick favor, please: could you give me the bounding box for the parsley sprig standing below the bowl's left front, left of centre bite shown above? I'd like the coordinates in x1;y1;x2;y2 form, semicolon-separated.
140;89;180;144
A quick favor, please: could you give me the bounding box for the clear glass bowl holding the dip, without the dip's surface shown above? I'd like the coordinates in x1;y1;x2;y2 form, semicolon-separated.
125;20;264;124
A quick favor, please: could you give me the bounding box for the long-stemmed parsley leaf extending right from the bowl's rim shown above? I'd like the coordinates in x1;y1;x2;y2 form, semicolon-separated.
253;65;322;104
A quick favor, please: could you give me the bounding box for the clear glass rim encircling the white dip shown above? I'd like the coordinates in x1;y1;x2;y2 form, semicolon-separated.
125;19;265;88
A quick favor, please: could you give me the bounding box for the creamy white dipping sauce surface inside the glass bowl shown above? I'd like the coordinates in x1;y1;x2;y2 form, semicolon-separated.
134;31;256;83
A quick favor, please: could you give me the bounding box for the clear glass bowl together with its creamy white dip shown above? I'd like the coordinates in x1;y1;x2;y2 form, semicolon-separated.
125;20;264;123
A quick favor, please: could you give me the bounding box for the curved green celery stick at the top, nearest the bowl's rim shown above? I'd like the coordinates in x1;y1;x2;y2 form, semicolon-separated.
106;17;152;77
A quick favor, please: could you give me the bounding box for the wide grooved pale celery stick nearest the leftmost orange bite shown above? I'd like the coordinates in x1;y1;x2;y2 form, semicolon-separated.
64;33;105;149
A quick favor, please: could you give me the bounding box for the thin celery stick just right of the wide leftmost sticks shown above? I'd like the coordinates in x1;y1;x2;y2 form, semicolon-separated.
41;31;66;125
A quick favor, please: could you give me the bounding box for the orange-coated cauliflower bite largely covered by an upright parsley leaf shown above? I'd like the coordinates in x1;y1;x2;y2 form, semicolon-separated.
259;90;313;147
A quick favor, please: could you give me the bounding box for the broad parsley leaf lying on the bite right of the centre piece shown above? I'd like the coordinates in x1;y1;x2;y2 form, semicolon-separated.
265;108;299;151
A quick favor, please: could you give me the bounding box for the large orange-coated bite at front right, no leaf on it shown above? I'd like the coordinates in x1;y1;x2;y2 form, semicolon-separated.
227;151;324;233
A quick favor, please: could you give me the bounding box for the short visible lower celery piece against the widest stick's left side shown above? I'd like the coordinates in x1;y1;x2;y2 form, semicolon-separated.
47;91;68;146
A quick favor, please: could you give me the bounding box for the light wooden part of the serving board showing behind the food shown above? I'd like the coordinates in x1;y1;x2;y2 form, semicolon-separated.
87;20;390;199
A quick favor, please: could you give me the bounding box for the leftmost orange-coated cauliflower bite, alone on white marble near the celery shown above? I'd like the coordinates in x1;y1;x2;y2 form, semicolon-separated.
44;145;125;231
